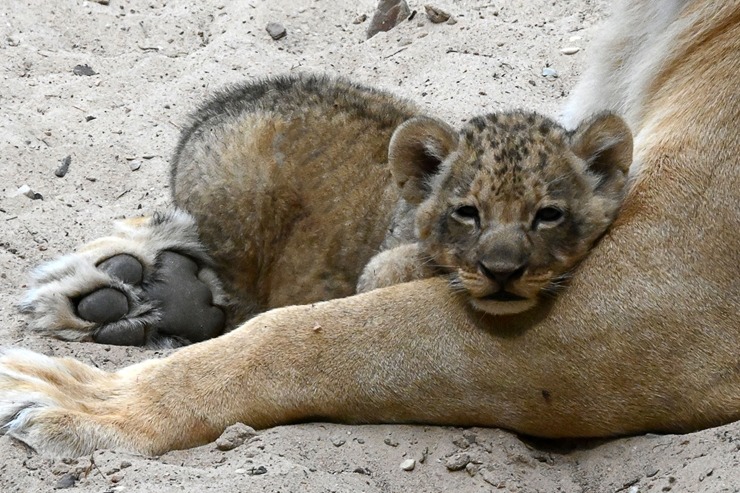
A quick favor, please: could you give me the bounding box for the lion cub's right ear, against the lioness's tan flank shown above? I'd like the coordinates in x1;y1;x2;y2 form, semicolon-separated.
571;113;632;198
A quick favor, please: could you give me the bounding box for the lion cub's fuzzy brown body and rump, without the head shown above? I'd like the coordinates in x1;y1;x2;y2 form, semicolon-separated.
171;75;418;318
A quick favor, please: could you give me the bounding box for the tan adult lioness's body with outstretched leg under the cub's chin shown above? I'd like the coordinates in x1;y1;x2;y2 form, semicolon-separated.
0;1;740;454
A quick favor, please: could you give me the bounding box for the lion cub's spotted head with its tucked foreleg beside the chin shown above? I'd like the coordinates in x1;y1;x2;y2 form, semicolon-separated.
358;111;632;314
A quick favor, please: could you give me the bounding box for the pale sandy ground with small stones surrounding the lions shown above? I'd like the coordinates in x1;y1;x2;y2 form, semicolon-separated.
0;0;740;493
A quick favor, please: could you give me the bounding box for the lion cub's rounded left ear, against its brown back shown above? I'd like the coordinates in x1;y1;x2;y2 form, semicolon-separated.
388;116;458;204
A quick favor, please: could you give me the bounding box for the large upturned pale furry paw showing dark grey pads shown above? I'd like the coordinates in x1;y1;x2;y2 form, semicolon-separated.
21;210;226;347
